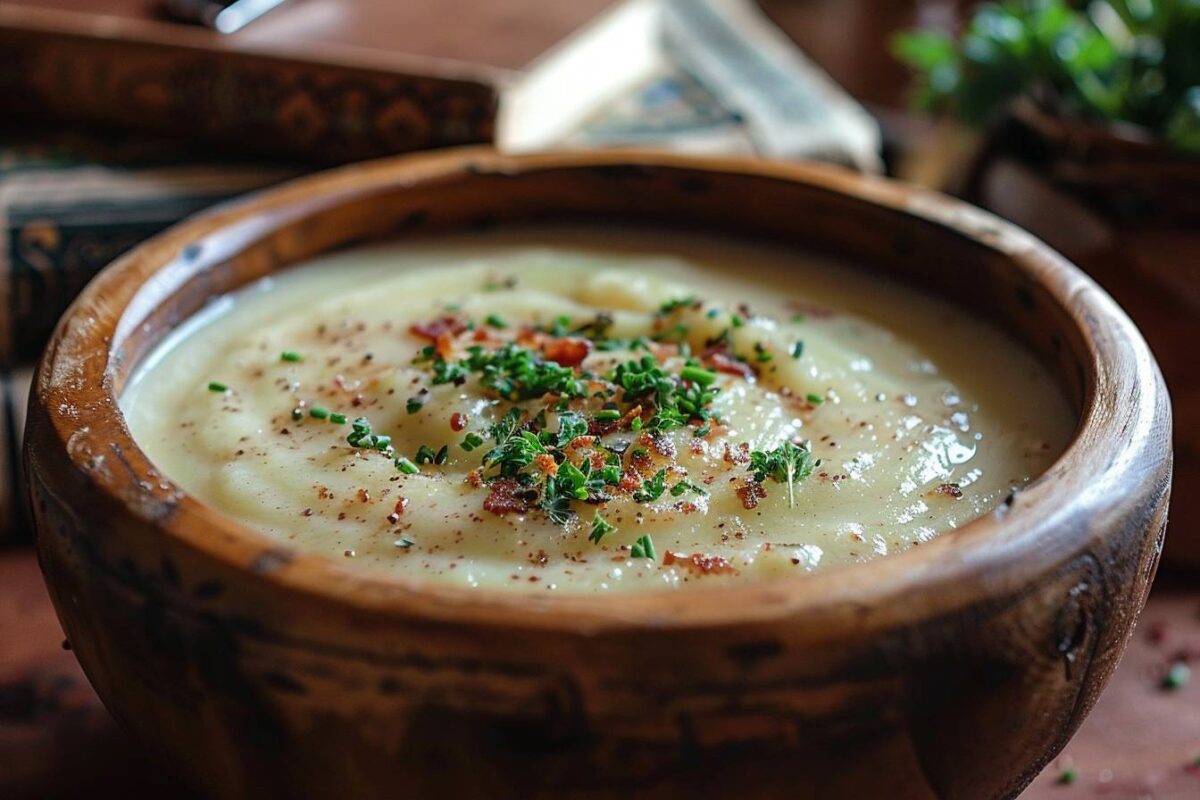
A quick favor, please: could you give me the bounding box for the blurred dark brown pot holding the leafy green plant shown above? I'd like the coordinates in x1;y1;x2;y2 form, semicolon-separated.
964;103;1200;569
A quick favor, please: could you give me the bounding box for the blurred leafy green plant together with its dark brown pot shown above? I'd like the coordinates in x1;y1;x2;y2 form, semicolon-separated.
894;0;1200;567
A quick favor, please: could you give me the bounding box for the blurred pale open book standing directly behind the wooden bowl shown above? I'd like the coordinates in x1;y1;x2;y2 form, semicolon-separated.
497;0;882;172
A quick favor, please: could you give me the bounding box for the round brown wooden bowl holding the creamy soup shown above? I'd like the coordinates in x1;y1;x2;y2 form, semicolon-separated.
25;150;1171;800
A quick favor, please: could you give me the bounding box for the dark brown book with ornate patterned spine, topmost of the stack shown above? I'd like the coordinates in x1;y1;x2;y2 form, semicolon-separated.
0;13;498;163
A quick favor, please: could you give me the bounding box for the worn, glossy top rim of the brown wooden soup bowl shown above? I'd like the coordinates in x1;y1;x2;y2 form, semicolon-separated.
35;148;1160;633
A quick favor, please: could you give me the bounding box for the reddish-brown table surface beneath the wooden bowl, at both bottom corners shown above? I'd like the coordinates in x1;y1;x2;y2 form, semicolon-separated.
0;551;1200;800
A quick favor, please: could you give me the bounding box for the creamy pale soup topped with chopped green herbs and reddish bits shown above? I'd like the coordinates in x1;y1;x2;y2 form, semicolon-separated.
121;229;1075;593
